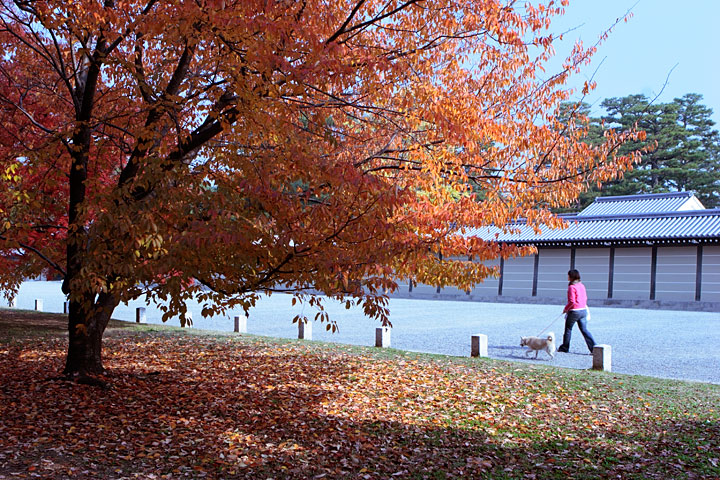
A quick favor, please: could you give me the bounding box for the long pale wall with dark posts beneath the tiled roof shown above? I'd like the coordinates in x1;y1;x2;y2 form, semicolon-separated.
402;245;720;308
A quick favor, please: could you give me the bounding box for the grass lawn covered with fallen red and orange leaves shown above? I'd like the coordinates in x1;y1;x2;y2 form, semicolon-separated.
0;309;720;479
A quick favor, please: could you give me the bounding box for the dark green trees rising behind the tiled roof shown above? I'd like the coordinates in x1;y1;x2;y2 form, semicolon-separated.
564;93;720;209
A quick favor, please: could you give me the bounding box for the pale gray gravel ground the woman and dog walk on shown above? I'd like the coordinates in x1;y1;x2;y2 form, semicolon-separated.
11;282;720;384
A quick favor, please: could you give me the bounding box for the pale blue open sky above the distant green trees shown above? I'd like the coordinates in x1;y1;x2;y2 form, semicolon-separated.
552;0;720;125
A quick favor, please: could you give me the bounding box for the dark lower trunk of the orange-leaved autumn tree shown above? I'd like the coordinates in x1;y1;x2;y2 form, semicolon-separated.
63;293;118;377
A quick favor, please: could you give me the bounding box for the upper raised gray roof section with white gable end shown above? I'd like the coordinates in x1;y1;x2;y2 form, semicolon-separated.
578;192;705;217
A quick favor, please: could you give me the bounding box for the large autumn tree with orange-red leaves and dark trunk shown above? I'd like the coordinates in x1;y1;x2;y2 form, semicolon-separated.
0;0;633;382
